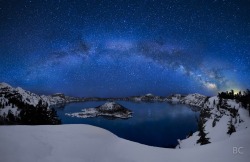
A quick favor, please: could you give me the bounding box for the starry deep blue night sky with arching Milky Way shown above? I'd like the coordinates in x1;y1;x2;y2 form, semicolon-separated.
0;0;250;97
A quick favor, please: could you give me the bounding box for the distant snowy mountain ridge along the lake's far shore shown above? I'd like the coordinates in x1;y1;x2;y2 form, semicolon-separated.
0;82;209;107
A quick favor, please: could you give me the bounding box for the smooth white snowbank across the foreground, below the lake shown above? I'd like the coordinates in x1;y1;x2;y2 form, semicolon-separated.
0;124;250;162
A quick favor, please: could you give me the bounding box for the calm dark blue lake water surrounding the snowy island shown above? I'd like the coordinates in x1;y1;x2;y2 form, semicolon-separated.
56;101;199;147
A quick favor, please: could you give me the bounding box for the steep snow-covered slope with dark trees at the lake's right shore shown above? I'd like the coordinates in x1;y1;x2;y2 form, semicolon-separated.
177;96;250;148
